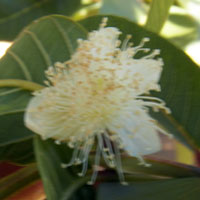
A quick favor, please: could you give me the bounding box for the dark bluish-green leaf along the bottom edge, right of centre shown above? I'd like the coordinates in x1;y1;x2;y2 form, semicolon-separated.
97;177;200;200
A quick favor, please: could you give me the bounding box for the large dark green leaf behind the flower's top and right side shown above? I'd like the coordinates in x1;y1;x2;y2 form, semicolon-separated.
80;16;200;148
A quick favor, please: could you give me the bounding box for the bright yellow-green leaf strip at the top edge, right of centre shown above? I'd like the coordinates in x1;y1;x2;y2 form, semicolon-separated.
145;0;174;33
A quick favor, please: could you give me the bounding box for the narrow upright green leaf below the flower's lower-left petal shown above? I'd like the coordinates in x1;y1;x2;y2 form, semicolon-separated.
34;136;88;200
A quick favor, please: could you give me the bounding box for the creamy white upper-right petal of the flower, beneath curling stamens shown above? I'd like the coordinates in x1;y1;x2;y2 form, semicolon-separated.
117;59;163;95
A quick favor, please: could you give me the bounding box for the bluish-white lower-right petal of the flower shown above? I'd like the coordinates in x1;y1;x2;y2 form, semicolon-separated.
109;109;161;157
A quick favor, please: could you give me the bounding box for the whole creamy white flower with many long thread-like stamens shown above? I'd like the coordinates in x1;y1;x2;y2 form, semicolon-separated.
25;19;172;183
